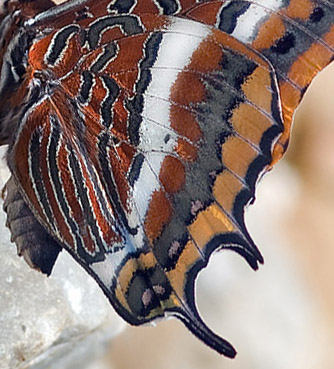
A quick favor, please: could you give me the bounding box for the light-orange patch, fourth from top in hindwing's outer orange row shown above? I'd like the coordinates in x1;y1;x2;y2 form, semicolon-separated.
213;170;243;214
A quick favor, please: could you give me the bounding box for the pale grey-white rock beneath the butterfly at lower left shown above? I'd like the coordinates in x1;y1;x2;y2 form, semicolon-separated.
0;147;125;369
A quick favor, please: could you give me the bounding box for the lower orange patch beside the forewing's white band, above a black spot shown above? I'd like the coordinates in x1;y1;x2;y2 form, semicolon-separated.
252;14;285;50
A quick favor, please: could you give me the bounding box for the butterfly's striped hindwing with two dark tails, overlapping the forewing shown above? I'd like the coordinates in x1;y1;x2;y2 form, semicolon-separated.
8;6;283;356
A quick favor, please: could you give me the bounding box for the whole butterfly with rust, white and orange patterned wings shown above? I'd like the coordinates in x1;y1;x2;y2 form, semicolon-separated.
0;0;334;357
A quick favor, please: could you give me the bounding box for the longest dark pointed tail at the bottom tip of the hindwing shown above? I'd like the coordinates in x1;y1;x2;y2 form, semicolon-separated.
177;311;237;359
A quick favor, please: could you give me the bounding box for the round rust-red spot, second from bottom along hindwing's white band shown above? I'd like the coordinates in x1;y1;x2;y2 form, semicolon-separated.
159;155;185;194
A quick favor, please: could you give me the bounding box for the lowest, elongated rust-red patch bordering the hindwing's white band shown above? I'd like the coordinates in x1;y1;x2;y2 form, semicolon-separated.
144;190;172;243
